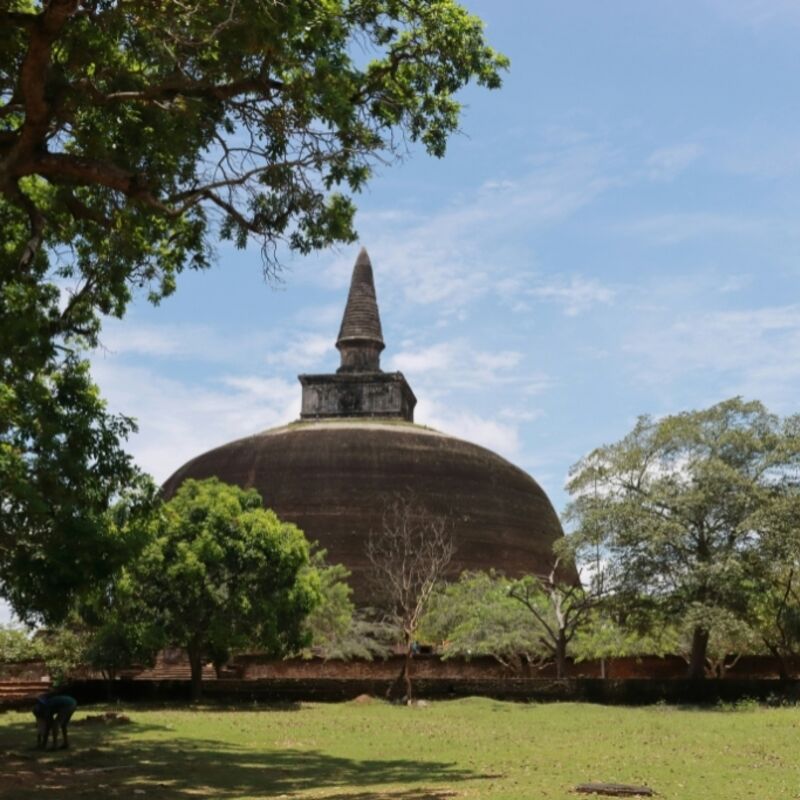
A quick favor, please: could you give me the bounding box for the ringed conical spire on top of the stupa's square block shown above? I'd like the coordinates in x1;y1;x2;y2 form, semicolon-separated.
336;247;385;372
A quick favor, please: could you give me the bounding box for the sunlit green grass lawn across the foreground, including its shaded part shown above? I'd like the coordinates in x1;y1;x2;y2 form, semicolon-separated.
0;698;800;800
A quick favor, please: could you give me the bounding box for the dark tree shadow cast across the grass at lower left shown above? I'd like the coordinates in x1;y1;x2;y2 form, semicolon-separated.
0;723;482;800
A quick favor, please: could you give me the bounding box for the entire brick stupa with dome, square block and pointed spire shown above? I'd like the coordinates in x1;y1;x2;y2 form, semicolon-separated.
164;249;563;603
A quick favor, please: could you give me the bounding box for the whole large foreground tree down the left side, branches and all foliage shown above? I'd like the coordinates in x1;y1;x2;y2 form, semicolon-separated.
0;0;506;618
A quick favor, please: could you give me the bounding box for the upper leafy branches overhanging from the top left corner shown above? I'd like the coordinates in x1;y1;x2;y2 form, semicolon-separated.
0;0;507;324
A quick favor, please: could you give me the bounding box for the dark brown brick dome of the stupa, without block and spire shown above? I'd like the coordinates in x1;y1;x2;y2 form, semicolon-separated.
164;419;562;602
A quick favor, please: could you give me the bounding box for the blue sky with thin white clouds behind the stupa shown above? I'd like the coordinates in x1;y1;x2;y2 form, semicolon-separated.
6;0;800;624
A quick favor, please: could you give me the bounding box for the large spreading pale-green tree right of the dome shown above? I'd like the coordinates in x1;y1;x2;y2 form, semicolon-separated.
567;398;800;678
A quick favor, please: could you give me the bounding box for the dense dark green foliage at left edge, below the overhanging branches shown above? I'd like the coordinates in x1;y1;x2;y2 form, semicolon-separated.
0;366;152;624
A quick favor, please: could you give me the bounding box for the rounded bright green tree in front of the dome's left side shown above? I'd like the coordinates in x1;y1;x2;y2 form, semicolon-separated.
134;478;320;699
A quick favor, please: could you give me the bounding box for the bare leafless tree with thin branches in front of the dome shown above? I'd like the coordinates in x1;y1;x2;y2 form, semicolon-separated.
367;493;455;701
